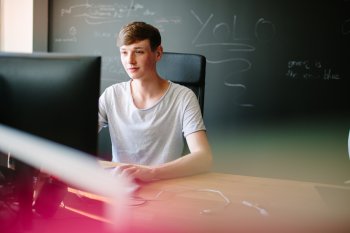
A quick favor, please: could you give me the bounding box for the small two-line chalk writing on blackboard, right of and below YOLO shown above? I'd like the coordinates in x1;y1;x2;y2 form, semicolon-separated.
286;60;341;80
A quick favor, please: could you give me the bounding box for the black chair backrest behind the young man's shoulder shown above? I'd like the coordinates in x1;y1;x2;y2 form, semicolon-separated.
157;52;206;114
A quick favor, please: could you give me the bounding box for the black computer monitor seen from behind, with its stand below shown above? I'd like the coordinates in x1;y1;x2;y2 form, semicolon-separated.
0;53;101;229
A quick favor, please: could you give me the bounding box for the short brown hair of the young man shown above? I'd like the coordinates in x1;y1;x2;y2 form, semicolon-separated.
117;22;162;51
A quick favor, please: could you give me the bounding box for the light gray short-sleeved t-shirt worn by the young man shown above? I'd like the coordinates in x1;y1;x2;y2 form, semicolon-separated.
99;81;205;165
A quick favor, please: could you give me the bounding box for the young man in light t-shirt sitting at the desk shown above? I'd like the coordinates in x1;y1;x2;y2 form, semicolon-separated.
99;22;212;181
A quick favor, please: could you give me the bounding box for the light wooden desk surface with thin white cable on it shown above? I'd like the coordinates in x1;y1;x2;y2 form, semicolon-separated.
27;162;350;233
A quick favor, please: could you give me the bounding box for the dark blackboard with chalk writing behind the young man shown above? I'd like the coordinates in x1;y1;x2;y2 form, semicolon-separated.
49;0;350;129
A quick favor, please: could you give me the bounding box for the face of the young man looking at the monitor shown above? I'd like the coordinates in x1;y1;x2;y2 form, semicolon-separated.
120;40;161;79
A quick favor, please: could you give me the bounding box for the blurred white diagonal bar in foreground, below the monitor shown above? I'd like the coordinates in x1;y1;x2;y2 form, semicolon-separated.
0;124;134;230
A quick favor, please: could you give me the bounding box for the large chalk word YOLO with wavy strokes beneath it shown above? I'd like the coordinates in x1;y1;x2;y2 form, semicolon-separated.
191;10;276;108
